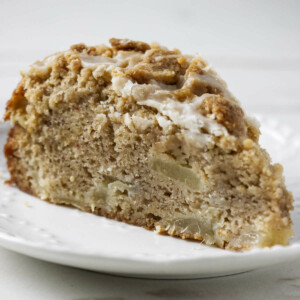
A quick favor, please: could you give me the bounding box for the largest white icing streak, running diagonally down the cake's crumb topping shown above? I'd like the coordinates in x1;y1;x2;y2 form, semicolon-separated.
112;77;228;147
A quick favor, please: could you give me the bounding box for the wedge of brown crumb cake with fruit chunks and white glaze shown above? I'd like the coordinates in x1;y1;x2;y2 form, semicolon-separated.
5;39;293;250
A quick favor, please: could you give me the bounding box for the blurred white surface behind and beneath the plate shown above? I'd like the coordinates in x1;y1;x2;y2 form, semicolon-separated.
0;0;300;300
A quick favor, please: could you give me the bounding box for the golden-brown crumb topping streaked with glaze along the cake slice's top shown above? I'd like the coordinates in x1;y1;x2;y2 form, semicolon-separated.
9;38;253;146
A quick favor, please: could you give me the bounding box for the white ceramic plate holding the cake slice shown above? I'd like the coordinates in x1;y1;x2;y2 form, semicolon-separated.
0;120;300;278
